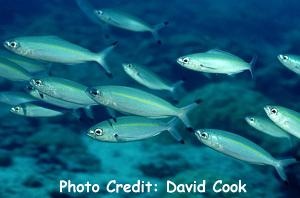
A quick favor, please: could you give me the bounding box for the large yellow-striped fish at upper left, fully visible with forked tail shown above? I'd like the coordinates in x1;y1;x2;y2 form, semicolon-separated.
4;35;117;77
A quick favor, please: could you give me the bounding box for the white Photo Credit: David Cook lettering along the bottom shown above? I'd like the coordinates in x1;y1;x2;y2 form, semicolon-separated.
59;179;248;194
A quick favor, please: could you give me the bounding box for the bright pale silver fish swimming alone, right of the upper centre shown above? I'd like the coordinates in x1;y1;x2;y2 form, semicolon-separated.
177;49;256;78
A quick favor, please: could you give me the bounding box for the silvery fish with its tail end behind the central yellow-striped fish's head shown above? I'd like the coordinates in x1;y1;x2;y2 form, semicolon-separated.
29;77;97;107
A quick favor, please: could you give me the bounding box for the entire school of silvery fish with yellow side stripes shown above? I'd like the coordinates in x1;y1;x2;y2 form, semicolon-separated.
0;0;300;181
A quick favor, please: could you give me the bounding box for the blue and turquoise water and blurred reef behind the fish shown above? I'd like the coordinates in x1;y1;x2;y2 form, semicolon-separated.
0;0;300;197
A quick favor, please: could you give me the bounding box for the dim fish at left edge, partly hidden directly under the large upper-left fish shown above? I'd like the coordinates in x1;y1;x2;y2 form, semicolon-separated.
0;50;50;74
